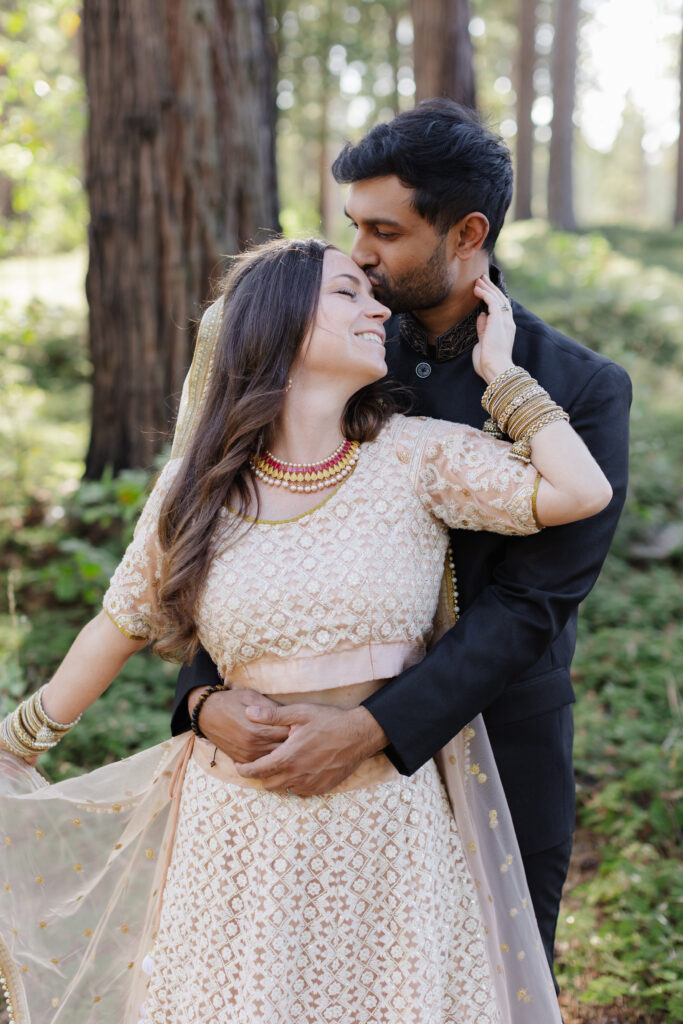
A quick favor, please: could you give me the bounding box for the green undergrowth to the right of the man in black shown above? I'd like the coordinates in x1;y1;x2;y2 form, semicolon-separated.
499;223;683;1024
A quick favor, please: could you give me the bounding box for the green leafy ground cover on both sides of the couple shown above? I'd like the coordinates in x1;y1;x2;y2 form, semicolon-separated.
0;222;683;1024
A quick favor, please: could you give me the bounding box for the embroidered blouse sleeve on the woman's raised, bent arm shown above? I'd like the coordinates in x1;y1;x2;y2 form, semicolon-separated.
396;417;542;535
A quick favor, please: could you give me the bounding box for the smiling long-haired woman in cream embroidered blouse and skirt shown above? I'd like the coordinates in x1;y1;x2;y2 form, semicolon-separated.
0;240;611;1024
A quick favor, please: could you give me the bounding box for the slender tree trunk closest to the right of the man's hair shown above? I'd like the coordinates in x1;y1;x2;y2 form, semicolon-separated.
515;0;537;220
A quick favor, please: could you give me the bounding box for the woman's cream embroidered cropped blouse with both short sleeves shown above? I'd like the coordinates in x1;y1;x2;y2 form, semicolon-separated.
103;415;541;694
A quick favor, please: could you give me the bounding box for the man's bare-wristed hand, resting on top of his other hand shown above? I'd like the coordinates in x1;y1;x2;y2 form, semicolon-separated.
232;703;388;797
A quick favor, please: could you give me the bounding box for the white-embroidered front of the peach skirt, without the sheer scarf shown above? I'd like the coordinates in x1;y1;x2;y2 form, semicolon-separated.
144;761;500;1024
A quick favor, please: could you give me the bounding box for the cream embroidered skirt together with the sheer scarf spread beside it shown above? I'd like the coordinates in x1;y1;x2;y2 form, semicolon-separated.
0;719;561;1024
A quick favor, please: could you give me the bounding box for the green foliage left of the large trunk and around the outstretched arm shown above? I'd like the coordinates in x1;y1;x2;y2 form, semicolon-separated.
0;280;176;778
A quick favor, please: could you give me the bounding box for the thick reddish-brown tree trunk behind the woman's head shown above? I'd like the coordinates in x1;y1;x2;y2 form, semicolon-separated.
83;0;279;477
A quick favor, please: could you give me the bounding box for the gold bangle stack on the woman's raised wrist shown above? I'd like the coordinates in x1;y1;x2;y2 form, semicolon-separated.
481;367;569;462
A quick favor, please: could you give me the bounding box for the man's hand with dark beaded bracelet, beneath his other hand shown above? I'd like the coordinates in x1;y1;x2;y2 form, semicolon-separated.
187;686;290;763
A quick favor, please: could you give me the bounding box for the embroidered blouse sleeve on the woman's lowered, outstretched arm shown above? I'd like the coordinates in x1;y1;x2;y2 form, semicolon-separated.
102;459;182;640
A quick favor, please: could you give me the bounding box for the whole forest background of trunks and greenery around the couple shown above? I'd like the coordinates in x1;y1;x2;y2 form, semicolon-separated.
0;0;683;1024
